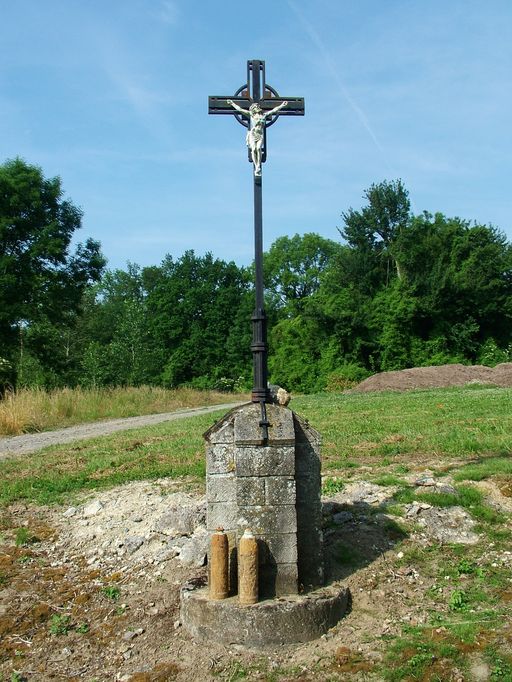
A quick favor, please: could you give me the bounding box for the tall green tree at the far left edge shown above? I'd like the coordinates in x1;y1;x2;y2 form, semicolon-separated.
0;158;105;386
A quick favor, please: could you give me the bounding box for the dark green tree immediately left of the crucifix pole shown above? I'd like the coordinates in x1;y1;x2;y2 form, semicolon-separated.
148;251;251;386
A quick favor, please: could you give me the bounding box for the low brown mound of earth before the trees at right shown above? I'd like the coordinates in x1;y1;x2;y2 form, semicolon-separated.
352;362;512;393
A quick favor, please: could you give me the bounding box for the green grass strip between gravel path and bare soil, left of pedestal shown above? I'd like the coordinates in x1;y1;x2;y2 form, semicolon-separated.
0;412;228;505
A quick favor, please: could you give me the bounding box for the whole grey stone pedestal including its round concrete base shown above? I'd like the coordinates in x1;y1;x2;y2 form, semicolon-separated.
180;403;350;648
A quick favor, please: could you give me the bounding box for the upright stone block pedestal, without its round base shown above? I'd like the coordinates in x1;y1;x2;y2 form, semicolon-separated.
205;403;323;599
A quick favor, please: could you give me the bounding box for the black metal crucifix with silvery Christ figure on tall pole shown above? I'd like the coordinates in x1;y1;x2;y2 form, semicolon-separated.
208;59;304;441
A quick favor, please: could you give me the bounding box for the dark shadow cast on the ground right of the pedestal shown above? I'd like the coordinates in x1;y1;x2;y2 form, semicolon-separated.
323;501;408;582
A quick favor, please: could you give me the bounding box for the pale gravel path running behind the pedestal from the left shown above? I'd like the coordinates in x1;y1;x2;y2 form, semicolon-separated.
0;403;243;460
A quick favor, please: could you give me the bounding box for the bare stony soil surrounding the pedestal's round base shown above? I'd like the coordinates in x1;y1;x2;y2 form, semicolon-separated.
0;463;512;682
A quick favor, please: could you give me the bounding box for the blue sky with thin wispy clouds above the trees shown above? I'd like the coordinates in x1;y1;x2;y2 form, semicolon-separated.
0;0;512;268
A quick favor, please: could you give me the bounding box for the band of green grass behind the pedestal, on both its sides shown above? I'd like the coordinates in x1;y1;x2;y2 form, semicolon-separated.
0;388;512;504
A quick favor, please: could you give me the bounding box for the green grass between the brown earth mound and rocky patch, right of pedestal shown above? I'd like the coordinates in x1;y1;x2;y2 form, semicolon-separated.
292;387;512;468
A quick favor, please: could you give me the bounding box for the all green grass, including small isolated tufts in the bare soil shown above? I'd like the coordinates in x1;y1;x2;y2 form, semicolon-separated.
0;387;512;681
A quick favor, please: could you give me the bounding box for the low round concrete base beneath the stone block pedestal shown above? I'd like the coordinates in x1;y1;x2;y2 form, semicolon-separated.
181;585;349;648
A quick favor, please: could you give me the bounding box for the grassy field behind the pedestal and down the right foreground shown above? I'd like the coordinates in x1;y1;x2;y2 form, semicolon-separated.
0;386;512;682
